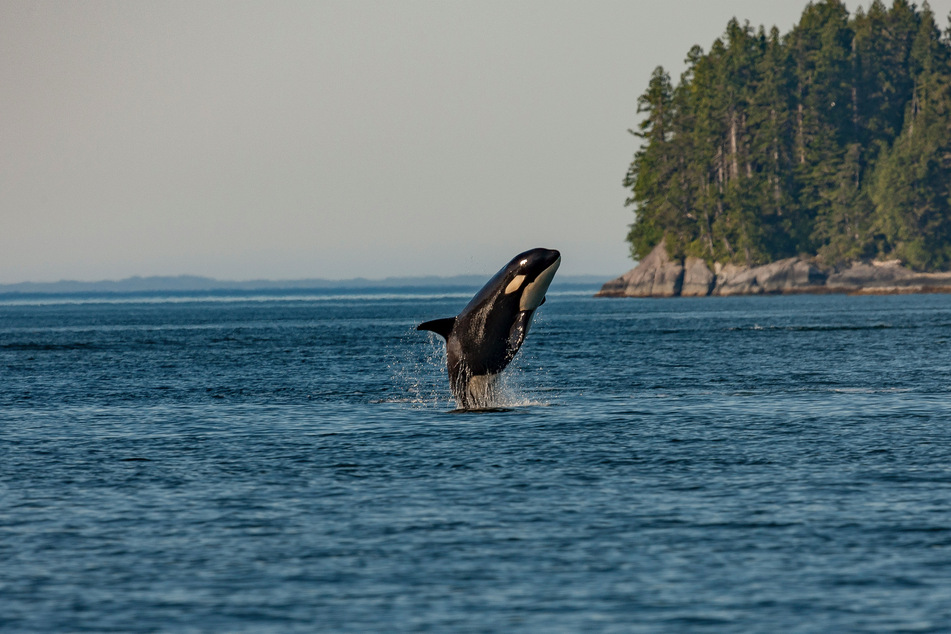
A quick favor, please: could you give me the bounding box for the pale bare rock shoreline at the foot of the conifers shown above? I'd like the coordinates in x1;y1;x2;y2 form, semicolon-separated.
595;243;951;297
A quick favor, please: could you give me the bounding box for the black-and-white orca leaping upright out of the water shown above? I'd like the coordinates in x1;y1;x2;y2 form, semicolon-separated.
416;244;561;409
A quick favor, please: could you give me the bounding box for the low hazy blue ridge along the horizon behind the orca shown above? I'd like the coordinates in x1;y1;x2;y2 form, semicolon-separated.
0;275;607;295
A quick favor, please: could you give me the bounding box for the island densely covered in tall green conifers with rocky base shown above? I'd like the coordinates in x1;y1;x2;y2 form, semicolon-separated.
603;0;951;295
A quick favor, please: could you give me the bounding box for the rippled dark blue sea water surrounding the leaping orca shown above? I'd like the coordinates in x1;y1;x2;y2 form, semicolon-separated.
0;292;951;632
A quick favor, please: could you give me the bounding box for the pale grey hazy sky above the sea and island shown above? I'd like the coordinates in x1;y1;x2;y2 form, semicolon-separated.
0;0;951;283
